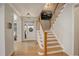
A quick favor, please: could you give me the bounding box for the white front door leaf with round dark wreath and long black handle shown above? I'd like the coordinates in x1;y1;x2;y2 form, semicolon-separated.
24;23;35;40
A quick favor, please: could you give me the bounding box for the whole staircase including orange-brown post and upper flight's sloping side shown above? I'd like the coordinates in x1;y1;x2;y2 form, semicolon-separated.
39;3;68;56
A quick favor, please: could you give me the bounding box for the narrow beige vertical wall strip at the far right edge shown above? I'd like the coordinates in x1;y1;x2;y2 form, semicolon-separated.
74;5;79;55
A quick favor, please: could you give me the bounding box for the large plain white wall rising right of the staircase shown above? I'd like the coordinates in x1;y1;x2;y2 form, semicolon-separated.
52;4;74;55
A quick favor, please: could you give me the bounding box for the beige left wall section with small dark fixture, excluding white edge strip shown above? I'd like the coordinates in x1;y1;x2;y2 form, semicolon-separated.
5;4;14;55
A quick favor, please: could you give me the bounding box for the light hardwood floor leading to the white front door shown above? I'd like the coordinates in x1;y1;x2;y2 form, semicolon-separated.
14;41;39;56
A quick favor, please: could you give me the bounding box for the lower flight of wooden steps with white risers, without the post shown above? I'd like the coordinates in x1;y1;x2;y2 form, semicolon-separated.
40;32;67;56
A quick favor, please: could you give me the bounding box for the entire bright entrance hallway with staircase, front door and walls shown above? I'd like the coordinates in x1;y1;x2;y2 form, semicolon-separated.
0;3;79;56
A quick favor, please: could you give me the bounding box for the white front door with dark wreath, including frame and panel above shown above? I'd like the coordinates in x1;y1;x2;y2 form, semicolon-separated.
23;18;36;41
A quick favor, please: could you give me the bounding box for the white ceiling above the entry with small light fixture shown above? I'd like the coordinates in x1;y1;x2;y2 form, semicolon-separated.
12;3;45;17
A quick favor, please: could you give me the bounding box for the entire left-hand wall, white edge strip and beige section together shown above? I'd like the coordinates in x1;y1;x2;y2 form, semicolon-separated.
0;4;14;56
